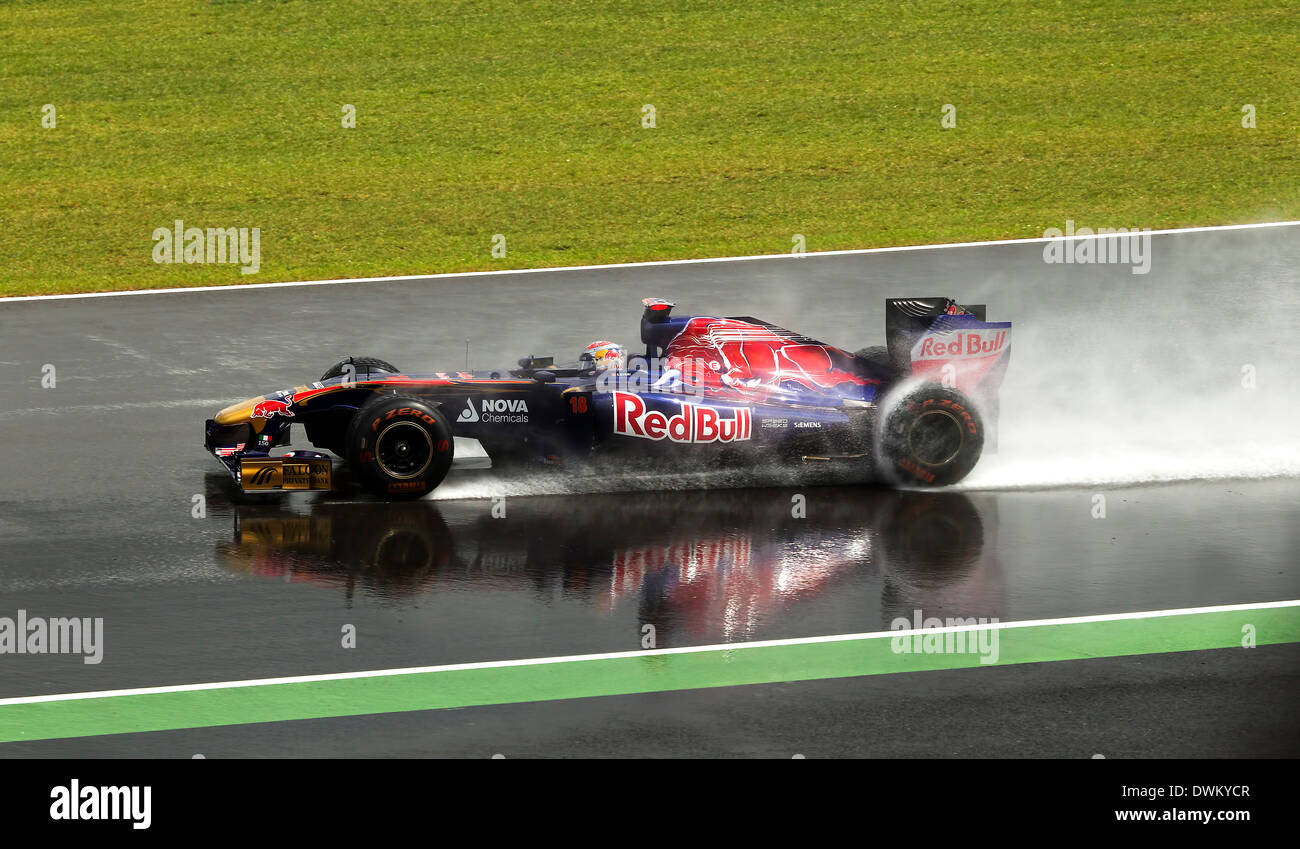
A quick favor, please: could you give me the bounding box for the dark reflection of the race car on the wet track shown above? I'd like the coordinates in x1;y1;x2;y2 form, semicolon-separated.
217;488;1004;644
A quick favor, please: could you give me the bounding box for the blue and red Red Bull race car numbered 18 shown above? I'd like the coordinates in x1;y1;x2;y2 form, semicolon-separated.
204;298;1011;499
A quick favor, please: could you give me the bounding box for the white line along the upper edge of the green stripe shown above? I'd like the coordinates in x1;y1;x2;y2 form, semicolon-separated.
0;599;1300;707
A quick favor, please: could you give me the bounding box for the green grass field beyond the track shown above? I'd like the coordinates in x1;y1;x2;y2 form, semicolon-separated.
0;0;1300;295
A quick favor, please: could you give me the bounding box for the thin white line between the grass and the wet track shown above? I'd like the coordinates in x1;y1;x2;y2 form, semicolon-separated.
0;221;1300;306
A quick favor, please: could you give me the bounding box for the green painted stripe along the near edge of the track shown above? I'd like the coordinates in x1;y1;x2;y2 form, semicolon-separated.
0;606;1300;742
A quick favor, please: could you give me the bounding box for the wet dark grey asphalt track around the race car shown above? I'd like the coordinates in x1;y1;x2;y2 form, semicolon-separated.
0;229;1300;757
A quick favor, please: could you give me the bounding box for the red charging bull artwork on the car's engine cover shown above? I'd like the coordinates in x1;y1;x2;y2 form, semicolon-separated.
664;317;876;395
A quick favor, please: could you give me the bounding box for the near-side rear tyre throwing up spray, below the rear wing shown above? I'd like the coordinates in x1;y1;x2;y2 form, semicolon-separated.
876;384;984;486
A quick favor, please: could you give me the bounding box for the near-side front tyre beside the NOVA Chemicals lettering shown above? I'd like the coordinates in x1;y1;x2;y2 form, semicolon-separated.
347;395;455;501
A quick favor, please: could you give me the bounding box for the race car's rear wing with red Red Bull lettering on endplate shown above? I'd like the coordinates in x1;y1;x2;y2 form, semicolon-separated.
885;298;1011;450
